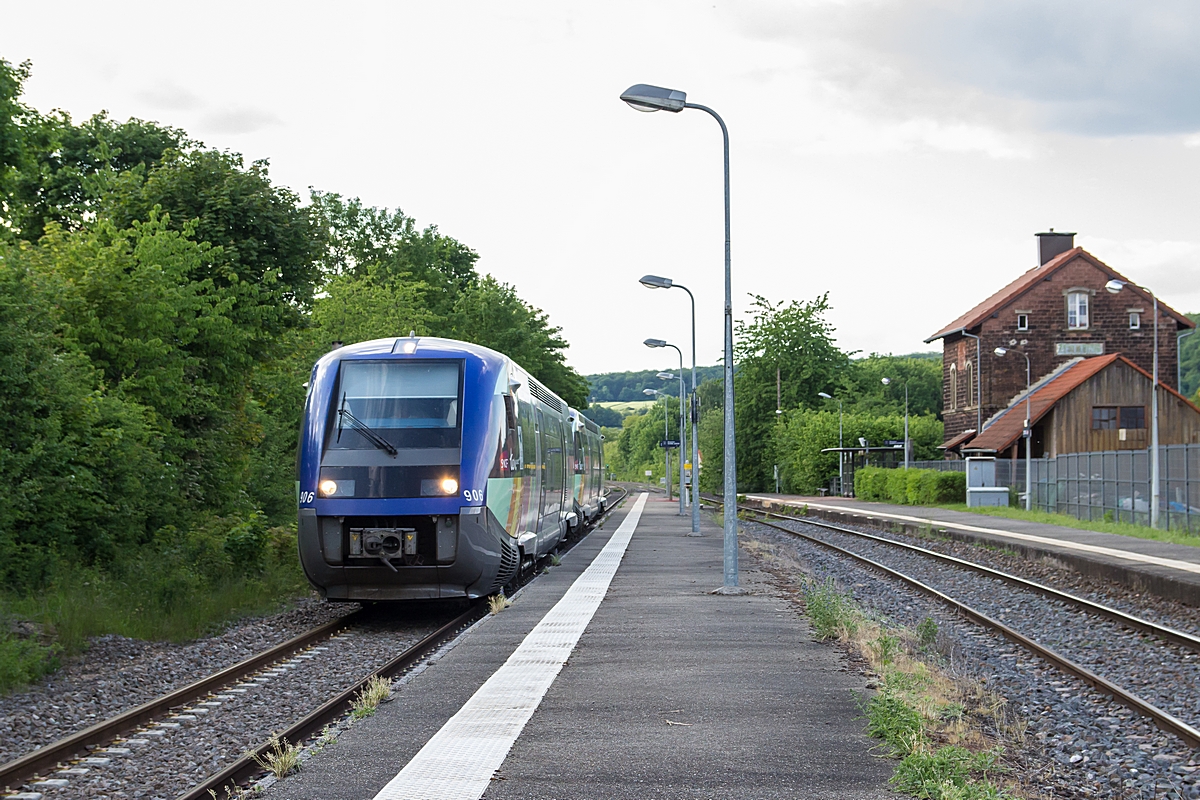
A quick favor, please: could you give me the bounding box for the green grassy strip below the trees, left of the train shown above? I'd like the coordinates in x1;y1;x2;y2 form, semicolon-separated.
0;528;307;693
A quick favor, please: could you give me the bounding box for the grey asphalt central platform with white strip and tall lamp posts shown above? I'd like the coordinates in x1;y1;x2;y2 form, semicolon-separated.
268;495;892;800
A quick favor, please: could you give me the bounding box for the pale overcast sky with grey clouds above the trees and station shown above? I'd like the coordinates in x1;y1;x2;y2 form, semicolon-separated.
0;0;1200;373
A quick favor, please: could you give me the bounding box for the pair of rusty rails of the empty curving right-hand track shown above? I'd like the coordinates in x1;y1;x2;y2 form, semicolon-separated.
710;499;1200;748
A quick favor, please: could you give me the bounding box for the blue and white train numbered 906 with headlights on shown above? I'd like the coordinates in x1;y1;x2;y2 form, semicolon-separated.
298;337;605;601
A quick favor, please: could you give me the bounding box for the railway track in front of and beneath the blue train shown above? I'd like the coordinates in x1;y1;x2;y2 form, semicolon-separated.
0;489;628;799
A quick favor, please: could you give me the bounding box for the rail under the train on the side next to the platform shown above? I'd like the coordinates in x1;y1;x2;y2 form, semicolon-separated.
175;487;629;800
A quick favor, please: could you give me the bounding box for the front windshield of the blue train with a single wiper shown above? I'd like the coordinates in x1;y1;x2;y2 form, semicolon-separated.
329;361;462;450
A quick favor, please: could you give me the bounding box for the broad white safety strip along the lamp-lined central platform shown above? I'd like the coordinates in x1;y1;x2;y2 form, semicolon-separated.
374;493;647;800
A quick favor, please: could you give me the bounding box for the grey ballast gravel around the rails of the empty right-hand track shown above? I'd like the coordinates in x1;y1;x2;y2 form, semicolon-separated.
743;519;1200;799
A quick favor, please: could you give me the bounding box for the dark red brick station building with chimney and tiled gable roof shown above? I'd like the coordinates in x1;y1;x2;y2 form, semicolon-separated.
925;229;1195;456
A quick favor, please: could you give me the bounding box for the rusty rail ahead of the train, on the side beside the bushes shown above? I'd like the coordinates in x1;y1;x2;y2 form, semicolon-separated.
0;609;362;786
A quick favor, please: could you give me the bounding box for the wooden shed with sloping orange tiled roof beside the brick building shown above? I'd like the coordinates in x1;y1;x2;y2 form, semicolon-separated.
962;354;1200;458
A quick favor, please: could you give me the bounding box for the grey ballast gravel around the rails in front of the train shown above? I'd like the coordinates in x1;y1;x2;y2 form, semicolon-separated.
5;602;452;800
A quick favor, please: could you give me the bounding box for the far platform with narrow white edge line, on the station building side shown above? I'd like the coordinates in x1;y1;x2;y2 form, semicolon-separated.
746;494;1200;606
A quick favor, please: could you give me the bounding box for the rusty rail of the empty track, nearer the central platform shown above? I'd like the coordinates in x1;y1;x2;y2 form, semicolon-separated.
713;500;1200;747
